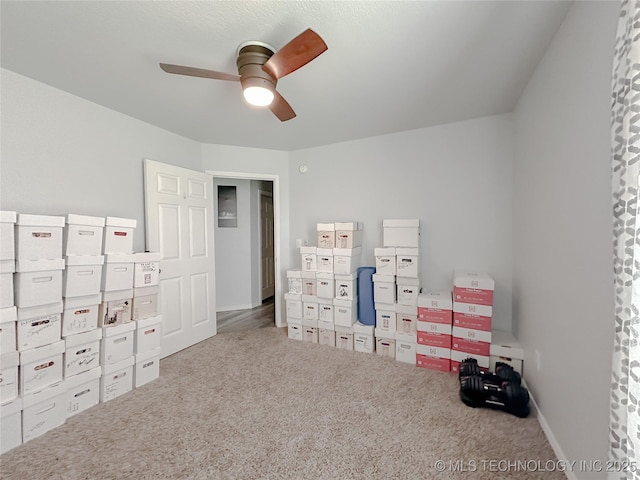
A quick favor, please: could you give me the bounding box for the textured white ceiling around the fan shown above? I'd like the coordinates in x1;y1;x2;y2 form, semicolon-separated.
0;0;570;150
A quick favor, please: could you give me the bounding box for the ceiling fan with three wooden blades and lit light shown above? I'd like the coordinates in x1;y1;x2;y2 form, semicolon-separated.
160;28;327;122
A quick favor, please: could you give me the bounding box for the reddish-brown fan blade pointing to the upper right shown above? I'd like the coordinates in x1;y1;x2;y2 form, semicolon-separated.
262;28;328;80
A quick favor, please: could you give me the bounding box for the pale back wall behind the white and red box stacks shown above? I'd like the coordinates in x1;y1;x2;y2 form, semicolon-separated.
285;115;514;330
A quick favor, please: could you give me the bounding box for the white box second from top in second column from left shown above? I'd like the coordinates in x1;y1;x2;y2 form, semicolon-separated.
13;258;64;308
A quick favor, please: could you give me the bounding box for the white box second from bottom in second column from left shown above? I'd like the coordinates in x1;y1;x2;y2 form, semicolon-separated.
20;340;64;397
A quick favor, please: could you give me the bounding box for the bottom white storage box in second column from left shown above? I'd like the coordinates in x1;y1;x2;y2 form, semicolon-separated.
22;381;67;443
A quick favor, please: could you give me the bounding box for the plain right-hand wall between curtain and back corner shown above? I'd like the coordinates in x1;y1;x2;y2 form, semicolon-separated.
513;2;619;472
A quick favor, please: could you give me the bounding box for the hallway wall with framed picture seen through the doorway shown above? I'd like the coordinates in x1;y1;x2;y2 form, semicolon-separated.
213;178;255;312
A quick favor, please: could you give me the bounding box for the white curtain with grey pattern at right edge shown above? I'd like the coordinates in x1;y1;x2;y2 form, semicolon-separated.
608;0;640;480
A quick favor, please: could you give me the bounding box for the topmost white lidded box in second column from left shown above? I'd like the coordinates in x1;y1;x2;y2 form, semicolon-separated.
15;213;65;260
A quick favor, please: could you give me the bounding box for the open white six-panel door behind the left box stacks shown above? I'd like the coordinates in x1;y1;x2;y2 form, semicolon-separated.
144;160;216;357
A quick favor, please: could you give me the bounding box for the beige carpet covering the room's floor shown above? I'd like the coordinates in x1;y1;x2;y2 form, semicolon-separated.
0;327;565;480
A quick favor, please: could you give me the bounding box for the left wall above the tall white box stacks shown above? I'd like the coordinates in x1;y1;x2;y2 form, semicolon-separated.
0;69;202;251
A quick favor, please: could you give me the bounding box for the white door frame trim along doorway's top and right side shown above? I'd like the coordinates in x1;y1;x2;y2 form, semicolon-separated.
204;170;286;328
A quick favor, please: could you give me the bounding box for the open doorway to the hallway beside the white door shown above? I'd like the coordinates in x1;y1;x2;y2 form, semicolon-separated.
208;172;279;333
